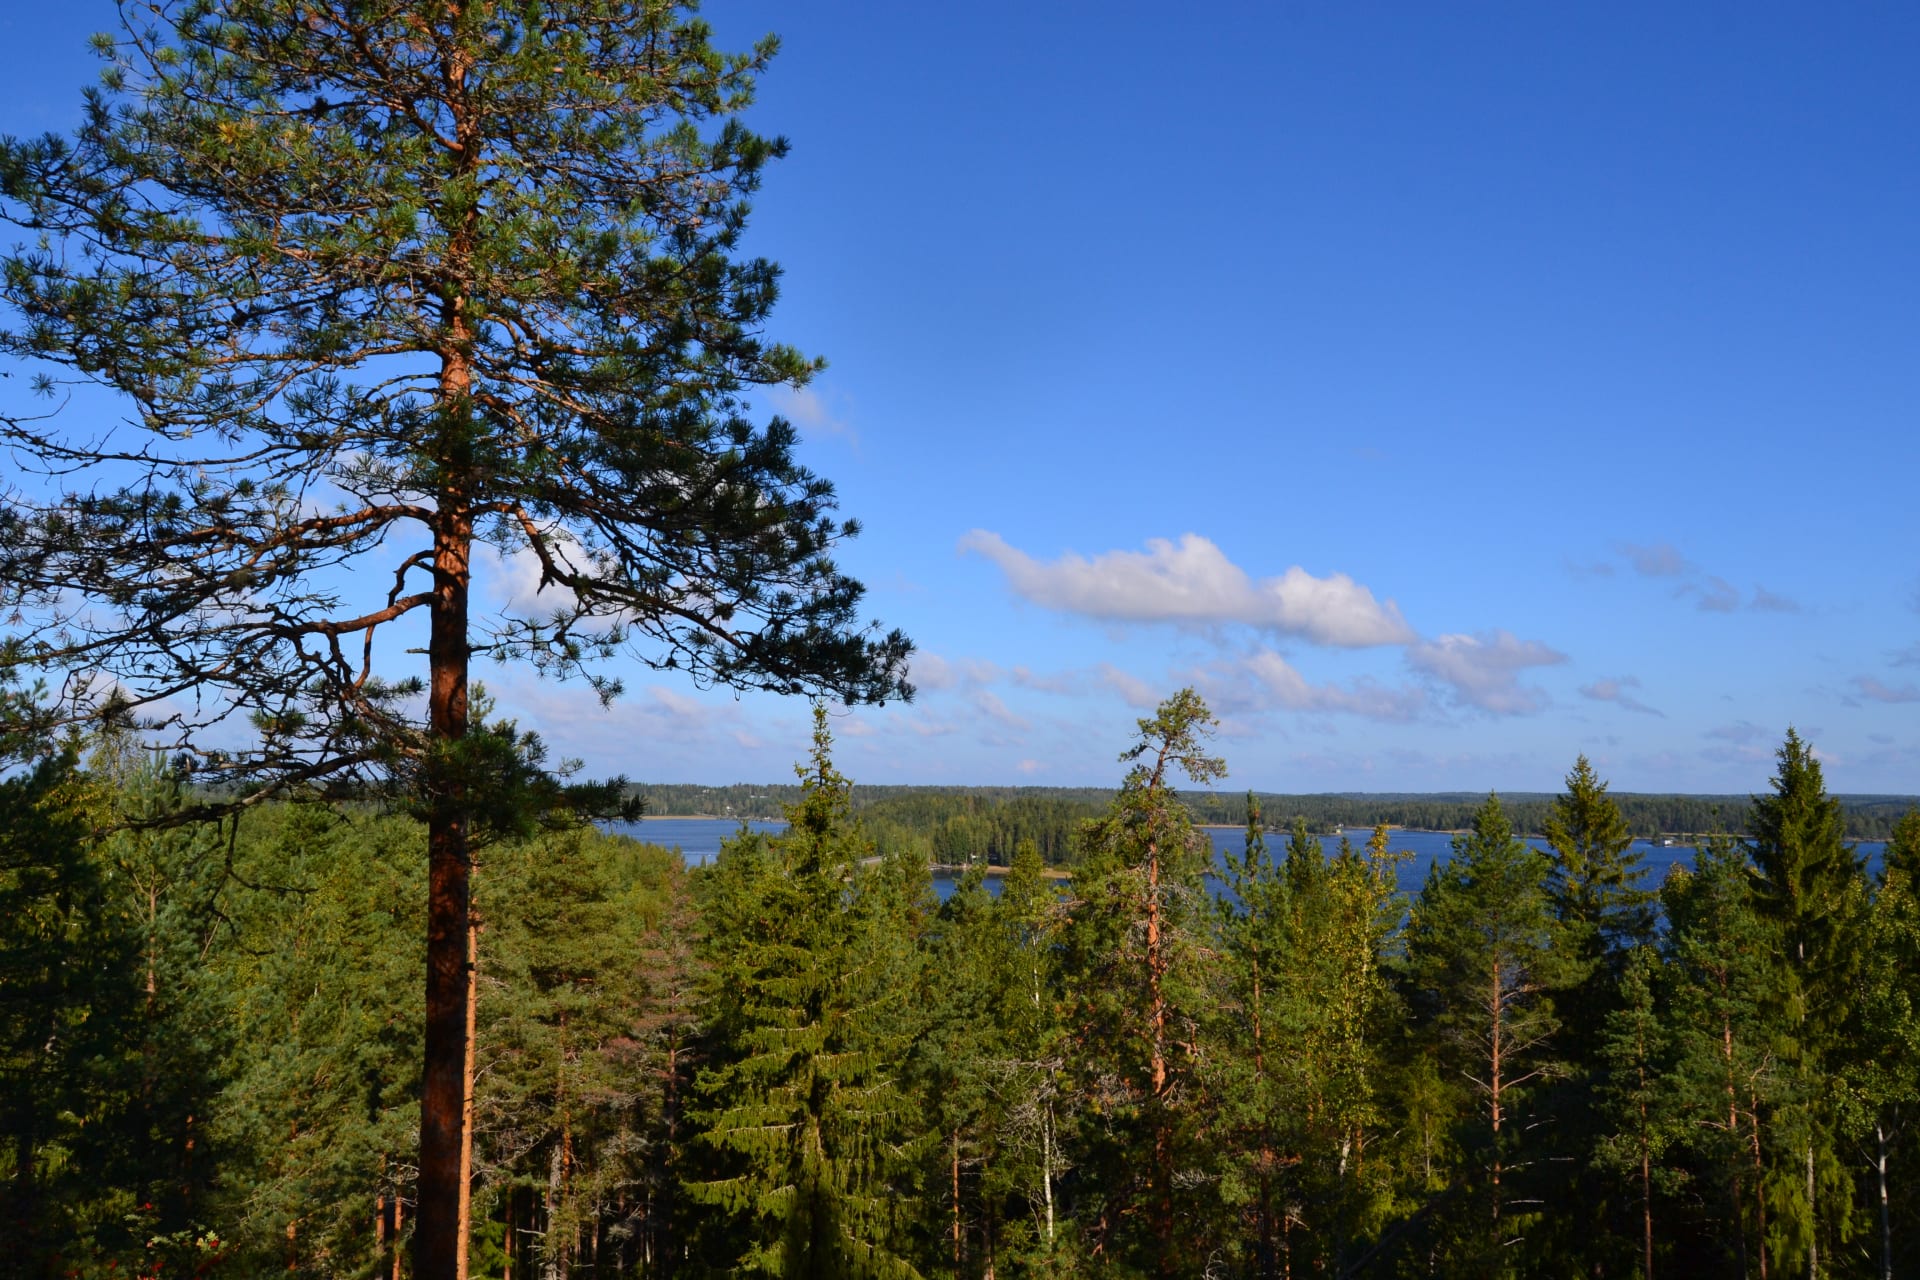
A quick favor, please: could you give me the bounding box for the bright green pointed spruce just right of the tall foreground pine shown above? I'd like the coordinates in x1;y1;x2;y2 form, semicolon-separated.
687;708;927;1280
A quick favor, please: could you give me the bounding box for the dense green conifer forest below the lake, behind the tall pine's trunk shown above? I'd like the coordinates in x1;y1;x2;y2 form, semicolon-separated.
0;693;1920;1276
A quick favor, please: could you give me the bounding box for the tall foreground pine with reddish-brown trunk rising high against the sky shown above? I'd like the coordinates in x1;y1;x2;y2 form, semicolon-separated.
0;0;908;1280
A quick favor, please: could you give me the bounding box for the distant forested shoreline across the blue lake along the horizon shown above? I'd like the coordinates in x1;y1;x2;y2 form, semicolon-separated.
630;783;1920;865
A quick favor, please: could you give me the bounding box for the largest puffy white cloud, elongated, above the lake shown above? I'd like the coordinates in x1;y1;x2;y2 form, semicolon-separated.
960;530;1413;649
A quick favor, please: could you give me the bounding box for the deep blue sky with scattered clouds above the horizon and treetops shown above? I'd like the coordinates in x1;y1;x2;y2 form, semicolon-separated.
0;0;1920;793
